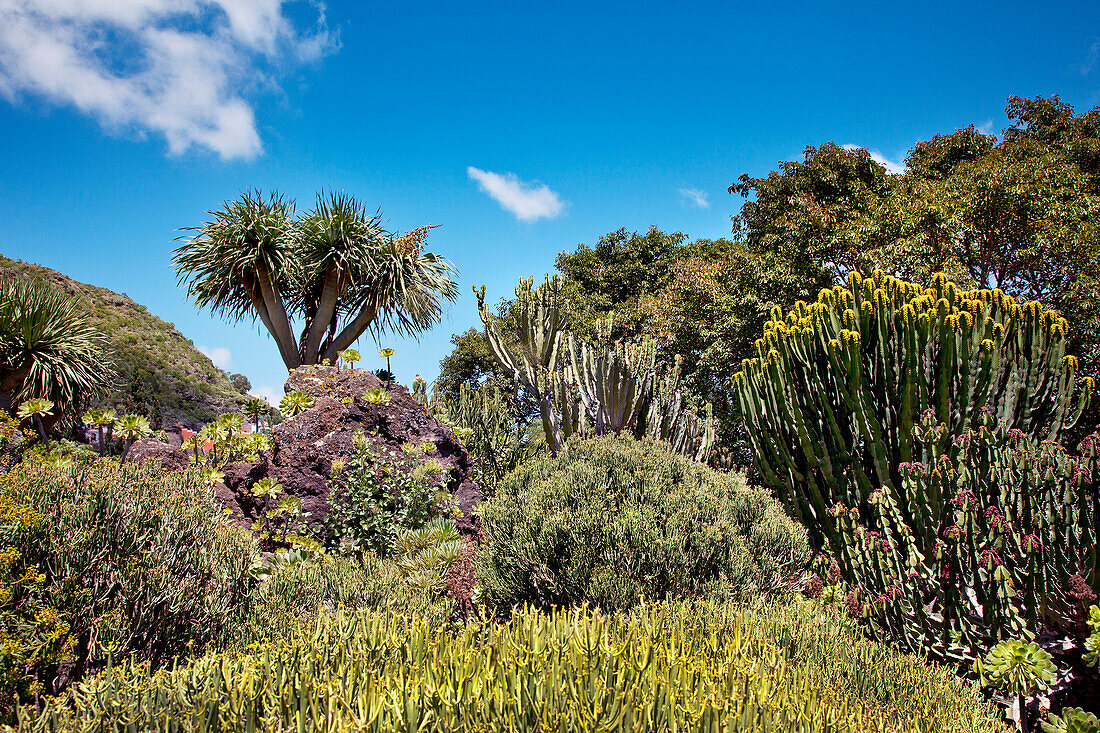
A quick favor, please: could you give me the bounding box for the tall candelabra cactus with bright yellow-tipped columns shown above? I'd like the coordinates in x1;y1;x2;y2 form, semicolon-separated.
735;271;1092;544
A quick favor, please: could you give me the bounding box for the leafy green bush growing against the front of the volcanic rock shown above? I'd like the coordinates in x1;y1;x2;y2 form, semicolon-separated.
328;433;454;557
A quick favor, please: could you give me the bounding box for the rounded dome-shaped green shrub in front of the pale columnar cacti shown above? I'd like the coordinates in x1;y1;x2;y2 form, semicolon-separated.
477;437;807;609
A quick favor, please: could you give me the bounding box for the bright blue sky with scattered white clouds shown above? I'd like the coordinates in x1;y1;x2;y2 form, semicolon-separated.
0;0;1100;402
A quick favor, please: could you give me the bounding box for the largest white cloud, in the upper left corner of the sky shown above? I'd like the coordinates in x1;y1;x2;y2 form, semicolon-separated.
0;0;337;158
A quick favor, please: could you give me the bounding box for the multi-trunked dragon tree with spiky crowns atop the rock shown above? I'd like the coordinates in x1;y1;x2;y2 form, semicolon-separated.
175;192;458;369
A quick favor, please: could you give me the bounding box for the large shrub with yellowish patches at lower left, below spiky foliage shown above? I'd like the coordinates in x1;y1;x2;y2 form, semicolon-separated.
0;460;253;708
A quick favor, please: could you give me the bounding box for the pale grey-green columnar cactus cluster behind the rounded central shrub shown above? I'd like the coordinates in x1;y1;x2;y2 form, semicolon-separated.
474;275;715;461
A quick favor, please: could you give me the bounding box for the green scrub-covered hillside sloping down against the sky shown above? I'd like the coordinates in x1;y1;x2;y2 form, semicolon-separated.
0;255;241;427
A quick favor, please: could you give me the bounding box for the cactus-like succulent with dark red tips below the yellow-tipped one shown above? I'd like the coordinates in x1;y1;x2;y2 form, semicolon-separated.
826;412;1100;661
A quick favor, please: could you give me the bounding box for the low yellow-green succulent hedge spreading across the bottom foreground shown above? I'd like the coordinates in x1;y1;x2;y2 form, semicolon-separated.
15;604;1003;733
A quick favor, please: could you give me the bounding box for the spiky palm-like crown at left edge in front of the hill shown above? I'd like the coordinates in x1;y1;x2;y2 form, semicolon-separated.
0;280;110;411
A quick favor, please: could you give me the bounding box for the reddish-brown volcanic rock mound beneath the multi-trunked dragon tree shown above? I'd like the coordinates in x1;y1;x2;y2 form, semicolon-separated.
219;367;482;535
